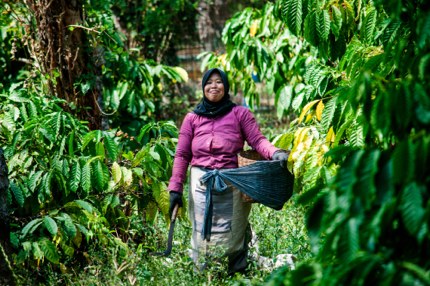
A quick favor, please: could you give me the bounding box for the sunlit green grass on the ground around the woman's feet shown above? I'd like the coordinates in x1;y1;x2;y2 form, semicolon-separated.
28;197;310;286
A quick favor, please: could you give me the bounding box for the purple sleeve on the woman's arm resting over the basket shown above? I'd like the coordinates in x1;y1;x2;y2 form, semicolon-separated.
239;108;279;160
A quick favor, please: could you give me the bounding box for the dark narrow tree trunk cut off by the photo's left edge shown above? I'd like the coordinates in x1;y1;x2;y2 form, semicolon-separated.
0;148;15;285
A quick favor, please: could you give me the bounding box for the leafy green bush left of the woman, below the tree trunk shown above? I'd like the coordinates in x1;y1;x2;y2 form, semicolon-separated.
0;82;177;272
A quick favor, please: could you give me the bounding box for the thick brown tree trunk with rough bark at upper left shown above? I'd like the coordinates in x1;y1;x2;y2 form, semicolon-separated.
26;0;102;129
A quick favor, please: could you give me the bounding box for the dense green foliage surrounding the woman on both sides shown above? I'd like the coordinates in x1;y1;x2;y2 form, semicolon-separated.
0;0;430;285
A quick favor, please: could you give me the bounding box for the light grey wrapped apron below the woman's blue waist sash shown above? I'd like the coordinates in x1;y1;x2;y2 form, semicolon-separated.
188;167;251;273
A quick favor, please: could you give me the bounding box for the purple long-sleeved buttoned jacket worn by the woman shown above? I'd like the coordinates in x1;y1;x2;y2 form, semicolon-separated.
168;106;278;192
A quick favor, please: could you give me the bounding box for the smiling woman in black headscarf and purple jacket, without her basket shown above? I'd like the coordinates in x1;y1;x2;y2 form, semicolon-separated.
168;68;288;274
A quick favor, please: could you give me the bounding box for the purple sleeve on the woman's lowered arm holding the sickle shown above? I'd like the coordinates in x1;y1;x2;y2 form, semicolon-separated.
168;113;193;193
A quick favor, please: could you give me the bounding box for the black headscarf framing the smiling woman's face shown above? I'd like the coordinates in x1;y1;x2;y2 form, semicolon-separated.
194;68;236;118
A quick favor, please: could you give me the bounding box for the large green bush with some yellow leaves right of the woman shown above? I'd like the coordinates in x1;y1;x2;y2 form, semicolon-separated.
205;0;430;285
